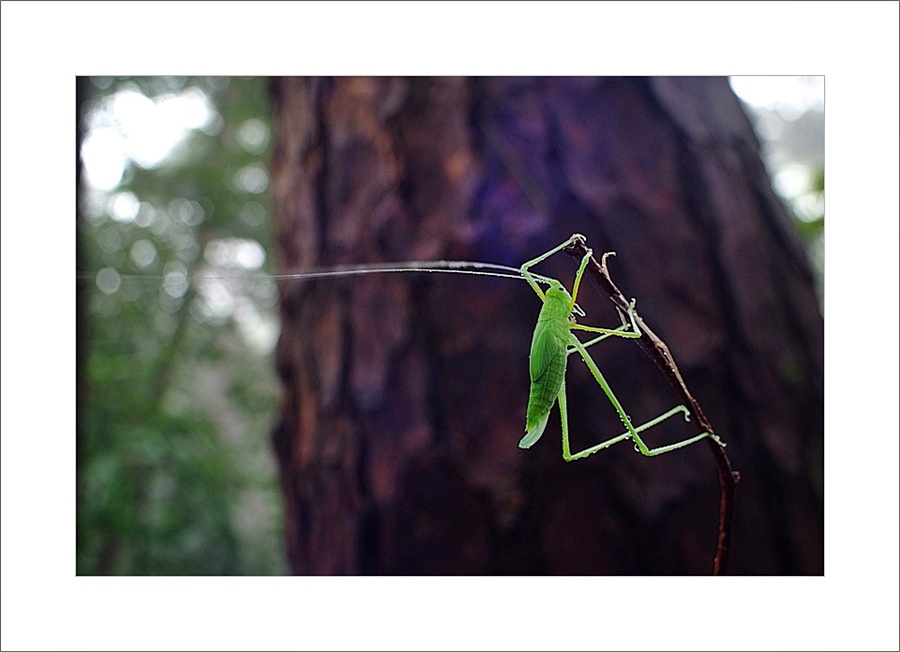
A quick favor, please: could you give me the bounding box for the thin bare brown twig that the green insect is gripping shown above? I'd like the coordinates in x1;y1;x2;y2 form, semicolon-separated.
563;234;741;575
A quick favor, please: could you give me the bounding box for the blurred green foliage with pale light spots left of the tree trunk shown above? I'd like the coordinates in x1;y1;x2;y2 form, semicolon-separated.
76;77;286;575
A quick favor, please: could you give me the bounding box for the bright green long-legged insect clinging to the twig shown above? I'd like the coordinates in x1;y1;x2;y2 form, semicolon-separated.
519;234;721;462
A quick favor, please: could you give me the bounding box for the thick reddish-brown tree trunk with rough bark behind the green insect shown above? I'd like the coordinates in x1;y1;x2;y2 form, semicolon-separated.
273;78;823;574
